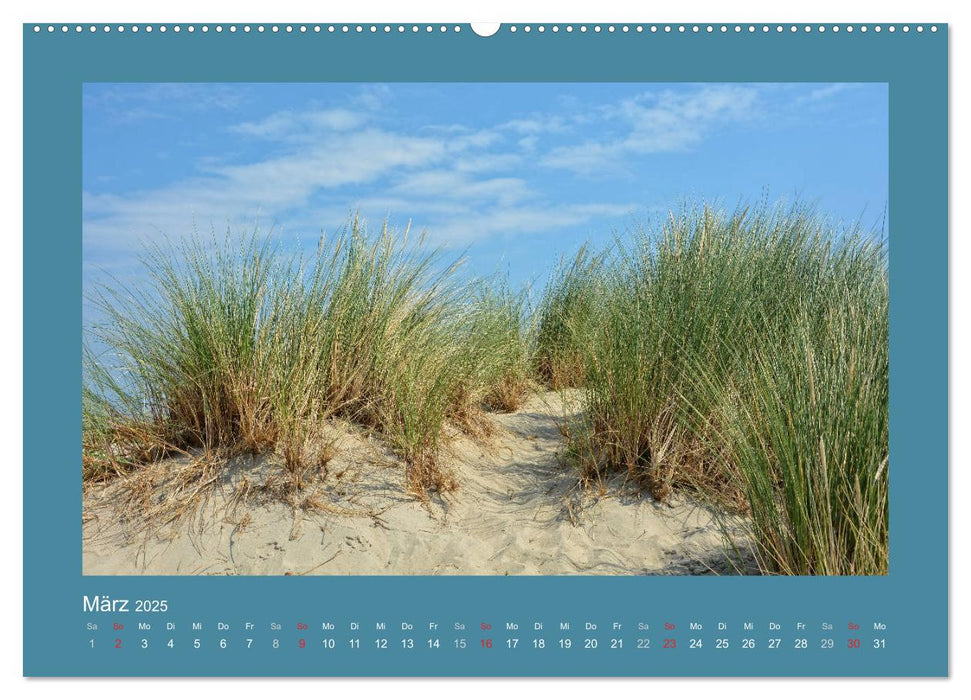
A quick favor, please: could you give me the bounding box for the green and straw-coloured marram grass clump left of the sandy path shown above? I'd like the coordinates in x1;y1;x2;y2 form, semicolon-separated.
82;219;527;495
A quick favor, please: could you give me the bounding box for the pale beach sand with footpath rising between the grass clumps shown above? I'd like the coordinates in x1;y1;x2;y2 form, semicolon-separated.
83;393;734;575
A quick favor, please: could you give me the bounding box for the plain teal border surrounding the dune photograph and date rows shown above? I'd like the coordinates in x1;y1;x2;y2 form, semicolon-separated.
23;24;948;676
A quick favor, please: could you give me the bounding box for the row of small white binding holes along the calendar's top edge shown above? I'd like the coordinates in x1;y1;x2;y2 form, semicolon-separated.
34;24;937;34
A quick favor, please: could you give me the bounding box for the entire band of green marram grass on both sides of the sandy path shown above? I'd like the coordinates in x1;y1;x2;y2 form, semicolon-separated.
82;201;889;574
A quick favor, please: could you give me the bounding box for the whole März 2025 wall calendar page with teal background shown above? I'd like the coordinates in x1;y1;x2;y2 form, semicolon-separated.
22;12;948;677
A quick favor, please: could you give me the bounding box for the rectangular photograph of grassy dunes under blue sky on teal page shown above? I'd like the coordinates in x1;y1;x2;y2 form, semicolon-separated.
77;82;891;576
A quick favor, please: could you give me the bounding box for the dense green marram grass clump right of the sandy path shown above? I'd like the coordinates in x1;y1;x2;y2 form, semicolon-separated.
548;202;888;574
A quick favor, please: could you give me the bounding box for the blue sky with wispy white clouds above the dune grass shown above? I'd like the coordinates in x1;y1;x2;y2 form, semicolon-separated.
83;83;888;292
